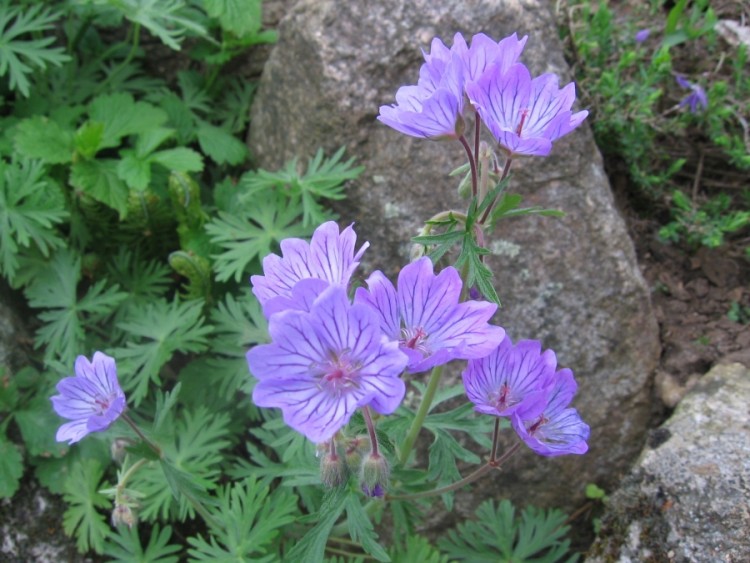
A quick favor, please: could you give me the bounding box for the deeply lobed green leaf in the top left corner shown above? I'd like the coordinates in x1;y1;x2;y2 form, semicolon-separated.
0;3;70;98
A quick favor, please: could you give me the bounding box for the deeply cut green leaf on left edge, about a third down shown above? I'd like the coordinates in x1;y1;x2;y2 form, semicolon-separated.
0;160;68;282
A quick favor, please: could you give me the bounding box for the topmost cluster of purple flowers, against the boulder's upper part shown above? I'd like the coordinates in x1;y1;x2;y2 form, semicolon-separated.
378;33;588;156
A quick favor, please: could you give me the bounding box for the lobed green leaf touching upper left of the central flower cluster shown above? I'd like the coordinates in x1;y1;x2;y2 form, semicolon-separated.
206;194;308;281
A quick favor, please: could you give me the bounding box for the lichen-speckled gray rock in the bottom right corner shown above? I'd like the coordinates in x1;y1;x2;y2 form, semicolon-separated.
588;364;750;563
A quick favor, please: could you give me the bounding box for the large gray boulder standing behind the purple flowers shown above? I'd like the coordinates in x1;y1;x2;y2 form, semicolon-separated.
249;0;659;512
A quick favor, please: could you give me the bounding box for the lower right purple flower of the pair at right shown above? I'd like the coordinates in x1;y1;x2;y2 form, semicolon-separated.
511;369;590;457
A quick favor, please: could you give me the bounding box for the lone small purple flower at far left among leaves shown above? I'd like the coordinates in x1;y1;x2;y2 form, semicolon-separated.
51;352;126;444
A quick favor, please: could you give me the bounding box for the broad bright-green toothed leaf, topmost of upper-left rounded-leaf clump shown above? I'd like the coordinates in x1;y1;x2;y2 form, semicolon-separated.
89;93;167;148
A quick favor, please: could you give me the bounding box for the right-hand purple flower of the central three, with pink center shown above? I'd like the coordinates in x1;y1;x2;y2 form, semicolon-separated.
354;257;505;373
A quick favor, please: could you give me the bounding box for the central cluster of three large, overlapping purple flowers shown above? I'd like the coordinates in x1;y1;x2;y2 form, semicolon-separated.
247;222;505;443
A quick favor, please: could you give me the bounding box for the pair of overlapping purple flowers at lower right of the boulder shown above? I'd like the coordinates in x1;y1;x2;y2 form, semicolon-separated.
463;337;589;456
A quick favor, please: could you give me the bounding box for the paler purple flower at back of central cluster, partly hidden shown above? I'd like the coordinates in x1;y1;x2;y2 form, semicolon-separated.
250;221;370;317
